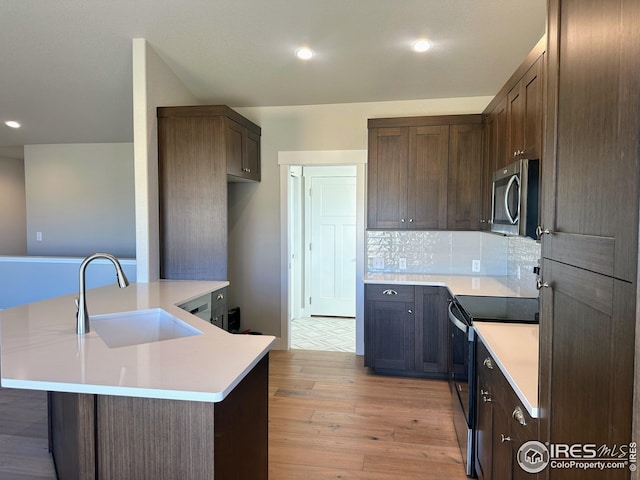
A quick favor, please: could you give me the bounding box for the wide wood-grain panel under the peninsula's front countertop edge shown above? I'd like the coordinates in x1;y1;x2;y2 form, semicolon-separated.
96;395;216;480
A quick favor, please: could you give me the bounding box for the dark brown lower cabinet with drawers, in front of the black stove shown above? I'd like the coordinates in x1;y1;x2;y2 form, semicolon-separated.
475;338;538;480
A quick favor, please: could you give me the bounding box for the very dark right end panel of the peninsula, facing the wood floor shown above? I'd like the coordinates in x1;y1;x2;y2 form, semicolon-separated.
215;353;269;480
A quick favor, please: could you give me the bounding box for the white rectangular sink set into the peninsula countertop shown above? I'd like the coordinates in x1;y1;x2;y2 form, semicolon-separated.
91;308;202;348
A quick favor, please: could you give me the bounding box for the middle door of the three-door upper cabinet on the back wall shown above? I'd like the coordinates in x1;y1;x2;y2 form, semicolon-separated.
408;125;449;230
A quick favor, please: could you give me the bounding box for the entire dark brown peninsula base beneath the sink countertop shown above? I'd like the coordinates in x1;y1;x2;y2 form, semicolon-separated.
49;355;269;480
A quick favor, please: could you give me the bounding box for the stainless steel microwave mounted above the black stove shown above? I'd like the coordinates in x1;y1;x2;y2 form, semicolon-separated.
491;159;540;238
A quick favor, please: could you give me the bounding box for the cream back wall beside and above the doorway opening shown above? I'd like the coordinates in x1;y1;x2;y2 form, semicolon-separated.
229;97;492;337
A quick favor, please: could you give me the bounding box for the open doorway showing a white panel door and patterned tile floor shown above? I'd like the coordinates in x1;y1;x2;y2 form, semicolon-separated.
288;165;357;352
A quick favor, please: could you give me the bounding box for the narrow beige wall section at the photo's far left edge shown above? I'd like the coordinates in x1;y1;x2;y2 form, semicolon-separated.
0;158;27;255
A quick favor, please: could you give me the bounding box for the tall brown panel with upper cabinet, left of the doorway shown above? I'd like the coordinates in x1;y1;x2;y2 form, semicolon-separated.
157;105;260;280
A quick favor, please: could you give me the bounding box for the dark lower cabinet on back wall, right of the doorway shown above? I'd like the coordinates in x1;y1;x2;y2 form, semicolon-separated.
364;284;448;378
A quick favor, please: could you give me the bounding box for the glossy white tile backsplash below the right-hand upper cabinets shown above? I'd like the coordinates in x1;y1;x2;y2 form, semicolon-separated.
367;230;540;280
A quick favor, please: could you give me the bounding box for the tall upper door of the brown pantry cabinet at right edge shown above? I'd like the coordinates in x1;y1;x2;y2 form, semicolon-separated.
542;0;640;282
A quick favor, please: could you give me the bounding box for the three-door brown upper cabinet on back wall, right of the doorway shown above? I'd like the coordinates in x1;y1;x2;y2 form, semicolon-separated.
367;115;482;230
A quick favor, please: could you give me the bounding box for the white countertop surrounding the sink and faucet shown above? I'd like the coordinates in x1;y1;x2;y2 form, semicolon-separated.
0;280;275;402
